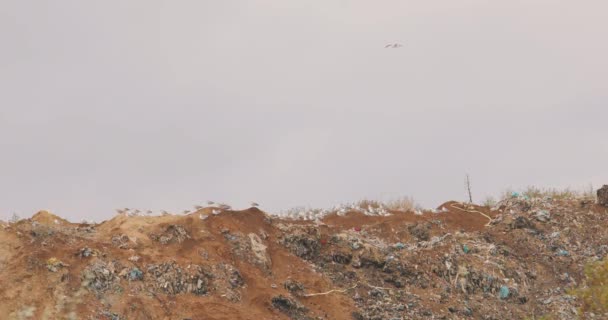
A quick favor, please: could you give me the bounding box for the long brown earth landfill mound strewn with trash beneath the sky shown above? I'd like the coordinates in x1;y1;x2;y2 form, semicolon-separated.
0;194;608;320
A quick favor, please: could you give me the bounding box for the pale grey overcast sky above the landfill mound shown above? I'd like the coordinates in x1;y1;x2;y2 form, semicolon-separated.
0;0;608;220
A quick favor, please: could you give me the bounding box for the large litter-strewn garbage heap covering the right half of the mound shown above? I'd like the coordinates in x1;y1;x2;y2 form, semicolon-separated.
272;194;608;320
